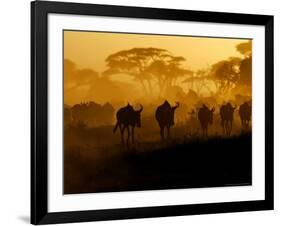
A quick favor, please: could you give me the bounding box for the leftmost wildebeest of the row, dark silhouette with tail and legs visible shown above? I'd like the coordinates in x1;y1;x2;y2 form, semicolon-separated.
113;104;143;146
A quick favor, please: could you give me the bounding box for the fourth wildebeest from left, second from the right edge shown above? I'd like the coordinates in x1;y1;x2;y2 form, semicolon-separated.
220;102;236;136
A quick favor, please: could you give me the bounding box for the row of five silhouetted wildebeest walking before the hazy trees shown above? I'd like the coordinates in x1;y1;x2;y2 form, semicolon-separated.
113;100;252;145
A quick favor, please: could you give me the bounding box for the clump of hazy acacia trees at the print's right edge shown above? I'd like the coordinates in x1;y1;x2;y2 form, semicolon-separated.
179;41;252;95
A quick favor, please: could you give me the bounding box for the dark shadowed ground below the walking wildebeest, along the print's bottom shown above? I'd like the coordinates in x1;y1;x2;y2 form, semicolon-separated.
64;125;252;194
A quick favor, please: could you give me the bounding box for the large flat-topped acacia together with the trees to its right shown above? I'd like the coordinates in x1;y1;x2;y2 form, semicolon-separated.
103;41;252;97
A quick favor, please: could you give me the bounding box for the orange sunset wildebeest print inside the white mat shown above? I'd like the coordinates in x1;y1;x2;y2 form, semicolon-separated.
63;30;253;194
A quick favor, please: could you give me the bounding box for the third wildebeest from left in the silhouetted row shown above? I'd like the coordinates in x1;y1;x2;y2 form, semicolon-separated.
198;104;215;136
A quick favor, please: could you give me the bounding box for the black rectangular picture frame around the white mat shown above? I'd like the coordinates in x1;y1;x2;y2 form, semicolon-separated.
31;1;274;224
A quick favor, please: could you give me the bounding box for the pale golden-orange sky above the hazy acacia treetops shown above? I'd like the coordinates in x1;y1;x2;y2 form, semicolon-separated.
64;31;247;105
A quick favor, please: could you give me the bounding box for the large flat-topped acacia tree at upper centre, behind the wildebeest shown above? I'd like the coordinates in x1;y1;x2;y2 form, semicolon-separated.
103;48;190;95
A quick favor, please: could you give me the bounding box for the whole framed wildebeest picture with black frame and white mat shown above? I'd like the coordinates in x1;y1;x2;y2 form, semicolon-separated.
31;1;273;224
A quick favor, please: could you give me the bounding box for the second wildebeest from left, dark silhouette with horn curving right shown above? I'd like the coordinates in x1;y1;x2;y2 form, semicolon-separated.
155;101;179;140
